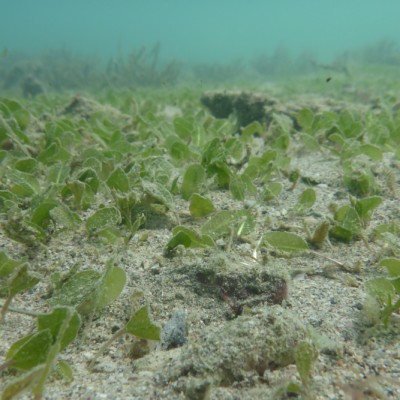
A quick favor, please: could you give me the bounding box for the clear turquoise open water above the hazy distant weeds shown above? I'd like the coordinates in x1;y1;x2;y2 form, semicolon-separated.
0;0;400;62
